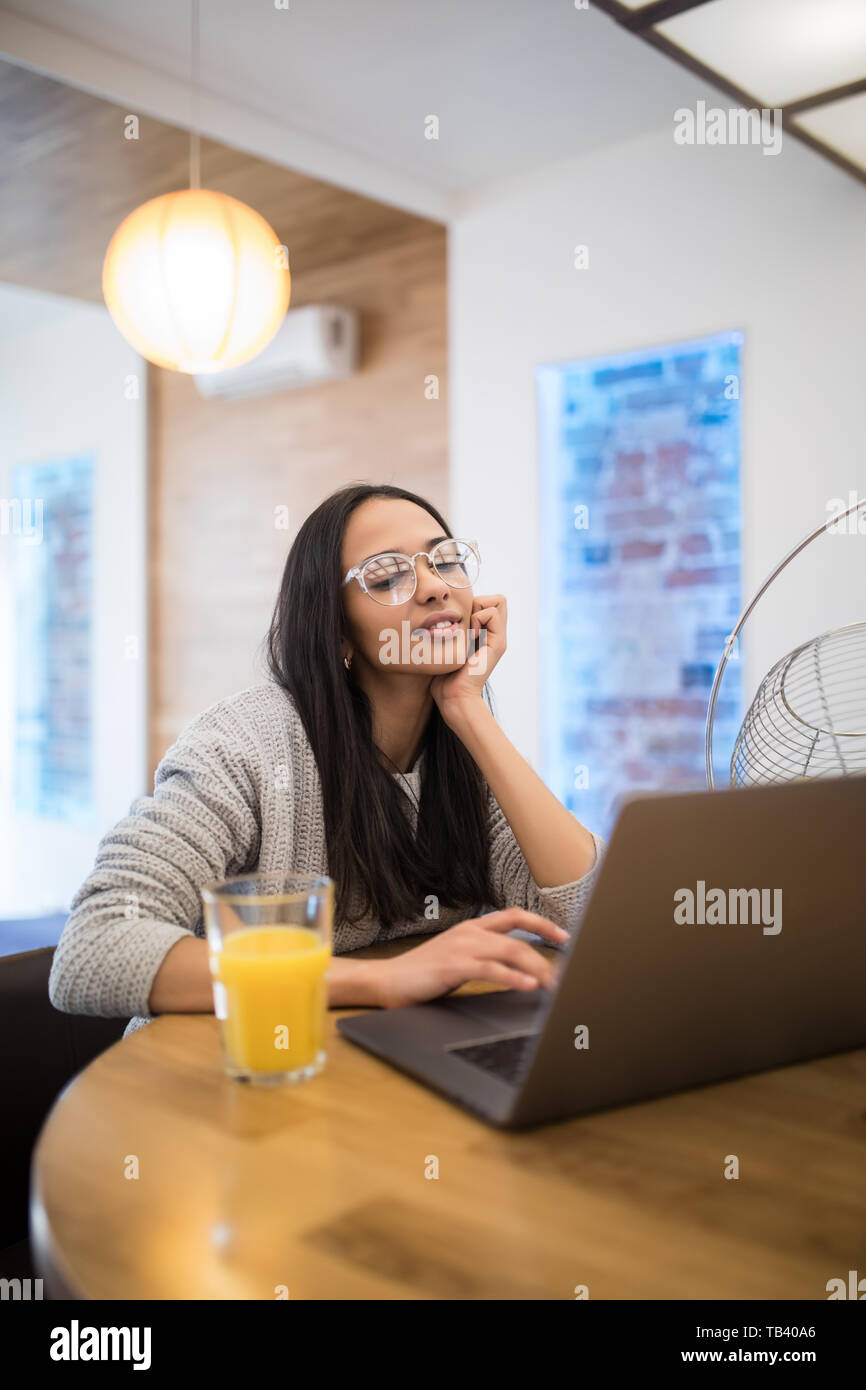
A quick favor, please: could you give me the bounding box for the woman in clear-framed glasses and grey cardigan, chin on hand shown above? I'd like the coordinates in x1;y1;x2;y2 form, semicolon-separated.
49;484;605;1033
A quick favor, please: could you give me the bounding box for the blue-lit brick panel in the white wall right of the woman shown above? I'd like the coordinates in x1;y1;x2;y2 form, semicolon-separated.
539;332;742;834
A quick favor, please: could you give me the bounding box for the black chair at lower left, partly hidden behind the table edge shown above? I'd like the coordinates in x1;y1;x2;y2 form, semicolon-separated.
0;947;129;1279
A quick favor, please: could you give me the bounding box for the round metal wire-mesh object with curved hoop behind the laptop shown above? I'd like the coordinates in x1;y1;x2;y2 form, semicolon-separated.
706;498;866;791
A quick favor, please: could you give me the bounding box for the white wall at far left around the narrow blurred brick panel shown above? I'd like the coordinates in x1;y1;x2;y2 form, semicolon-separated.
0;285;150;919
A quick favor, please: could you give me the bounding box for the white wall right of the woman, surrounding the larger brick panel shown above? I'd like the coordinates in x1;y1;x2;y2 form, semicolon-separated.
449;120;866;767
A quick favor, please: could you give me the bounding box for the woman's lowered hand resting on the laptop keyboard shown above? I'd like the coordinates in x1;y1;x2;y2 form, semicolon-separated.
377;908;569;1009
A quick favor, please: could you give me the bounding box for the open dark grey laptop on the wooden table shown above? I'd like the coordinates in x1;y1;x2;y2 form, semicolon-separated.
336;774;866;1129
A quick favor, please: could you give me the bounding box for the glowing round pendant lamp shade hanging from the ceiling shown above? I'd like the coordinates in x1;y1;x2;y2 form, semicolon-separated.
103;189;291;373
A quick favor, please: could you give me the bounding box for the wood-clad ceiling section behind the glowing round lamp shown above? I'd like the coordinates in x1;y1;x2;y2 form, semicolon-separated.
0;60;433;307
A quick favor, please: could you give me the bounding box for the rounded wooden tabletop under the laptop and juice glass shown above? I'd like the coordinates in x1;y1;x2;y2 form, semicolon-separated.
31;938;866;1300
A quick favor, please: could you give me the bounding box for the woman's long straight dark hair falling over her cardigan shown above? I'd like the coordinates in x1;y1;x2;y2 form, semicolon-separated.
265;484;499;927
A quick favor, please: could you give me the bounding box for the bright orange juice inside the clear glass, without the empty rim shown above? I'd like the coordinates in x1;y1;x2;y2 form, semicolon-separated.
211;927;331;1072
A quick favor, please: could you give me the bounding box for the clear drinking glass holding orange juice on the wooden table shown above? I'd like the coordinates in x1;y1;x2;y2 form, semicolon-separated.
202;872;334;1086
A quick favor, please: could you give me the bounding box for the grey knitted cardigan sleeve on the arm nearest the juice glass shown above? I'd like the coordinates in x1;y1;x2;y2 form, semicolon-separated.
49;701;261;1017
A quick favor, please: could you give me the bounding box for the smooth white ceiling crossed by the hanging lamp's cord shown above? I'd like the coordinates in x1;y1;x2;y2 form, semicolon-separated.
0;0;706;221
